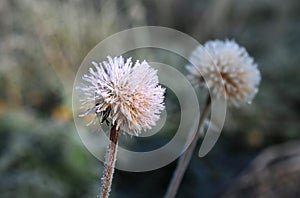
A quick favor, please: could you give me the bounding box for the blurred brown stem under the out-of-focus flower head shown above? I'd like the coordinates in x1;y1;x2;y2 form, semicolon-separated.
165;96;211;198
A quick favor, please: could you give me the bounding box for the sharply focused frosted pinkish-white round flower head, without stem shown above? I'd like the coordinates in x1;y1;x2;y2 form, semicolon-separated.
76;56;165;135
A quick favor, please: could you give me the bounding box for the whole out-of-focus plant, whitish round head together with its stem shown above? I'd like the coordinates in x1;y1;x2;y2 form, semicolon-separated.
165;40;261;198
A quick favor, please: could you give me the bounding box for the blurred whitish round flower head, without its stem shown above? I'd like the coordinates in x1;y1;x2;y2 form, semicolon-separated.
187;40;261;106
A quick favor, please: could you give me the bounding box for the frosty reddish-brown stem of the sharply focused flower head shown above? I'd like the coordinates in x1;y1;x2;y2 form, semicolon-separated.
99;125;118;198
